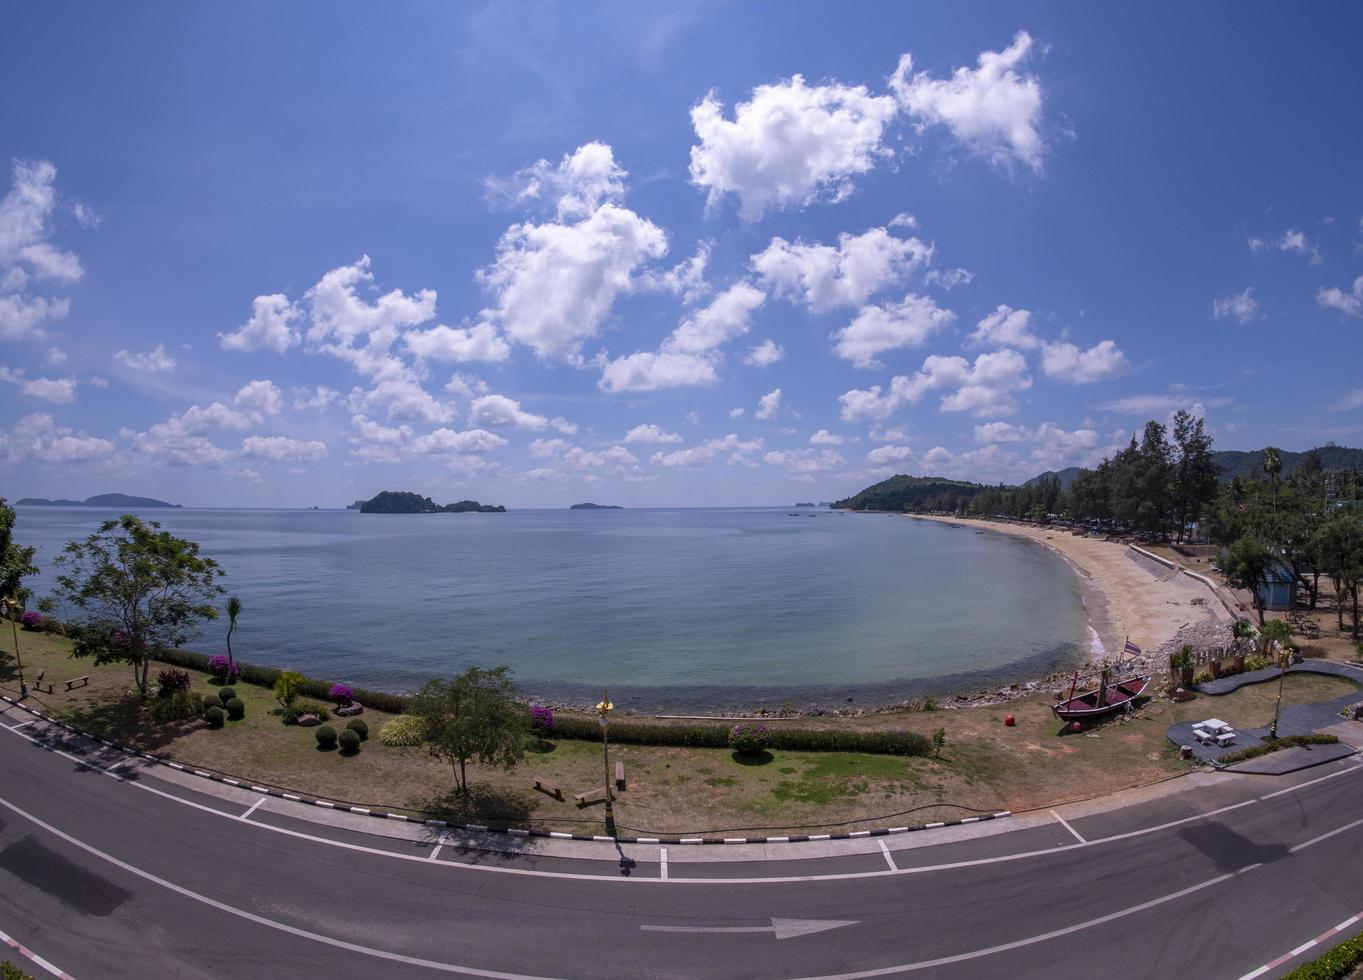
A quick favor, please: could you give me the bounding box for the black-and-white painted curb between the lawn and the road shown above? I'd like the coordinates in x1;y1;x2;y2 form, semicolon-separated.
0;694;1013;845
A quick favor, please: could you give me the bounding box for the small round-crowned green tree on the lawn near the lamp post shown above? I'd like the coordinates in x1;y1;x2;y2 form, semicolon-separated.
408;665;529;797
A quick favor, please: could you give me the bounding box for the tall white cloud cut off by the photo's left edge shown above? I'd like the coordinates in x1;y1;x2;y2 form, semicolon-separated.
0;159;83;339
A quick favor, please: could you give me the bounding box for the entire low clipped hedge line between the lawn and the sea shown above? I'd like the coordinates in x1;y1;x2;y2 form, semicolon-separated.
157;650;937;755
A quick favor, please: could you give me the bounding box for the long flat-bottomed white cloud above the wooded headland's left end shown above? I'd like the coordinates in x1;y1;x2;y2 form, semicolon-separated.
840;349;1032;423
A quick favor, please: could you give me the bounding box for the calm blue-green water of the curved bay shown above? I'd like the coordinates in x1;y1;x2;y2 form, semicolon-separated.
15;507;1088;710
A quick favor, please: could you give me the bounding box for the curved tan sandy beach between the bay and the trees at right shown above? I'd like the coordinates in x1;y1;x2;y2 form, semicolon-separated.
913;515;1229;658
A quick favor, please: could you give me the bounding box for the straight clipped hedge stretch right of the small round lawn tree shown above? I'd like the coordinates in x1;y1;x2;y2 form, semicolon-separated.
553;717;932;755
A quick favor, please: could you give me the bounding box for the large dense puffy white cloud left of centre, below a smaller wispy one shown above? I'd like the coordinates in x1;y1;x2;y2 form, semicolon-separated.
478;204;668;361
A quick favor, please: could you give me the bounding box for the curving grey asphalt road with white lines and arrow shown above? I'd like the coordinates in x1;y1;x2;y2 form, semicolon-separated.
0;711;1363;980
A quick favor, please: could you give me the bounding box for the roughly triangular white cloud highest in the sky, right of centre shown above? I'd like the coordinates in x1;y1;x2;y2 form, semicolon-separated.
890;31;1045;172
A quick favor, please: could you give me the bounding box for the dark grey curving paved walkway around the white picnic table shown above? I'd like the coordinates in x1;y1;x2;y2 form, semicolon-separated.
1168;660;1363;774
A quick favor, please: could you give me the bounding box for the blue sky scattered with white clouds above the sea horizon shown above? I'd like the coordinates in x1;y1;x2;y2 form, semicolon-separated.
0;3;1363;507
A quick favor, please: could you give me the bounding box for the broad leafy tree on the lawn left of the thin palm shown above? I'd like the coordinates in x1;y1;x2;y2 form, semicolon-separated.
55;514;224;695
